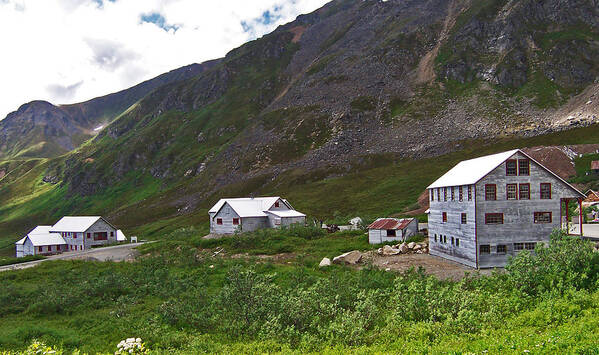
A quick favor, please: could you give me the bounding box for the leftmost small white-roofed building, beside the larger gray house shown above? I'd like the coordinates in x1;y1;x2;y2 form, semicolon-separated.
15;226;67;258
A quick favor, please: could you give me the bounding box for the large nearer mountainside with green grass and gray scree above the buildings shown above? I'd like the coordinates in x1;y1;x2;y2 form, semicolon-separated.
0;0;599;246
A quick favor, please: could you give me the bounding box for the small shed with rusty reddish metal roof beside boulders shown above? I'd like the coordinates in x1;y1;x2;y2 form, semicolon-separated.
368;218;418;244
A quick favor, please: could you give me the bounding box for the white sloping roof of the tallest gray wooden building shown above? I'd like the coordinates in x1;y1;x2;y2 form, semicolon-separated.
428;149;519;189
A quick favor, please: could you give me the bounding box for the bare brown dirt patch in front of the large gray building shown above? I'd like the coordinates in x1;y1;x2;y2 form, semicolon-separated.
363;252;491;281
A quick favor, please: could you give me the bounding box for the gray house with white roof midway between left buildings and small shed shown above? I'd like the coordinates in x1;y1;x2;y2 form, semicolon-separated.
208;197;306;234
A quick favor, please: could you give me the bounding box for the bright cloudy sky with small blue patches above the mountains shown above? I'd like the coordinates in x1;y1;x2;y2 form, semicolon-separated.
0;0;329;119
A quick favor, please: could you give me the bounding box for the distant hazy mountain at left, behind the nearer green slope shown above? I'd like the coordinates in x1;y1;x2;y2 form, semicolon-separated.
0;60;218;160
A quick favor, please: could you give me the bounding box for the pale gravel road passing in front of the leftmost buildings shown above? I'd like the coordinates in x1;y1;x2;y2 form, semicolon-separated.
0;242;144;271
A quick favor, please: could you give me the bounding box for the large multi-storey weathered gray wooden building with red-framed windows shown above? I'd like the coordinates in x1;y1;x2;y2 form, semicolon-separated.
428;149;585;268
